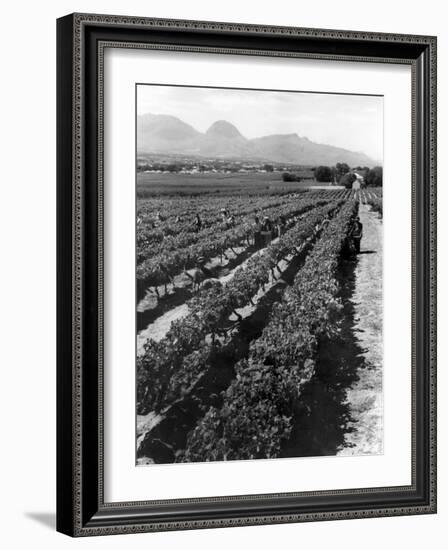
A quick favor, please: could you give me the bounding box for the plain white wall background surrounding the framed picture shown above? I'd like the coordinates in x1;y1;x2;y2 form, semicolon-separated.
0;0;448;550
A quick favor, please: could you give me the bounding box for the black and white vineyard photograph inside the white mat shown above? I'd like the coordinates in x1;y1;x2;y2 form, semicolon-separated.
135;83;387;466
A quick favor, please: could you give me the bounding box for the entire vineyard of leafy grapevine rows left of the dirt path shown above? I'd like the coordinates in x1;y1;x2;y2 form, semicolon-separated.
136;188;382;464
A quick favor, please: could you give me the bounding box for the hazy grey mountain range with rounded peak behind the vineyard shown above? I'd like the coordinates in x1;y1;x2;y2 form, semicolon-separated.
137;113;376;166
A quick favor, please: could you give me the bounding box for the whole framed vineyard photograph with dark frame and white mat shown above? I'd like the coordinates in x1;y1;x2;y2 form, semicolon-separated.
57;14;436;536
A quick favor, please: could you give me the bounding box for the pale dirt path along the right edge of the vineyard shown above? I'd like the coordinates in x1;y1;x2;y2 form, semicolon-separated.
338;204;383;455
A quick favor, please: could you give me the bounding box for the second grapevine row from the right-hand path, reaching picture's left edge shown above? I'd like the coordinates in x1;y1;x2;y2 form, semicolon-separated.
137;203;339;414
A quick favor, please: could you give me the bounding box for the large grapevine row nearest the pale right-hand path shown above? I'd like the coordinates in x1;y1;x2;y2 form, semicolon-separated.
178;201;358;462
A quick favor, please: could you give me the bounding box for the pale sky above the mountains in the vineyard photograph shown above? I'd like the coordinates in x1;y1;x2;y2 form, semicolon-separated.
137;85;383;164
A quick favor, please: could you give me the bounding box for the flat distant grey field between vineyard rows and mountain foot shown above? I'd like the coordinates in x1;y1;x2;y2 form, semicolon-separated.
137;172;319;198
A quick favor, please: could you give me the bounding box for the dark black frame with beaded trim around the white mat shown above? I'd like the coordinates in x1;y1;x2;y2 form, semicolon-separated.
57;14;436;536
